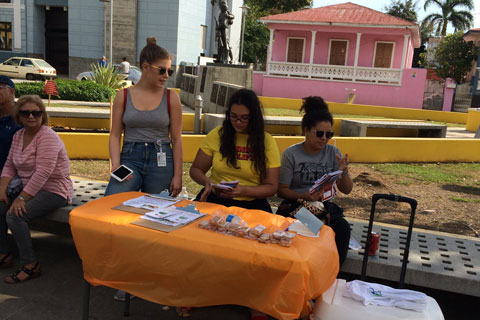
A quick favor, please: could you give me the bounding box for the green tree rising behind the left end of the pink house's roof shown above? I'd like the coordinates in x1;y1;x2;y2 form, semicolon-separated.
243;0;313;70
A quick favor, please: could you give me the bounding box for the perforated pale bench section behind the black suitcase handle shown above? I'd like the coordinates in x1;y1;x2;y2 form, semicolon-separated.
341;218;480;297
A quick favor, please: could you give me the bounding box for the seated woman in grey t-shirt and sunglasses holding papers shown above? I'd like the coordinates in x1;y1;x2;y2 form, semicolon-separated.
277;97;353;265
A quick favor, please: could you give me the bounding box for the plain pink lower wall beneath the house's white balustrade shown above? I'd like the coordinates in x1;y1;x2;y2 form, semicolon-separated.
253;69;427;109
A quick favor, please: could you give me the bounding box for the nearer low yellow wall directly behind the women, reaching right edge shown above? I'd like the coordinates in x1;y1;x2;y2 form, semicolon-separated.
58;132;480;163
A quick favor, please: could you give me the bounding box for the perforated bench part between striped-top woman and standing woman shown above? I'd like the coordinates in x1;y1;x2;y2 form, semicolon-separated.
45;179;107;223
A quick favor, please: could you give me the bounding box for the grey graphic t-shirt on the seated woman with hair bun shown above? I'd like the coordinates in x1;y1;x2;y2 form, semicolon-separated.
280;142;342;193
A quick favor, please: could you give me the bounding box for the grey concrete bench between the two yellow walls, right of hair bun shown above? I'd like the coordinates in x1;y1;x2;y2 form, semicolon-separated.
340;120;447;138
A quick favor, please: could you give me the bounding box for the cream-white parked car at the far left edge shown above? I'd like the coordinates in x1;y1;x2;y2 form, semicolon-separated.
0;57;57;80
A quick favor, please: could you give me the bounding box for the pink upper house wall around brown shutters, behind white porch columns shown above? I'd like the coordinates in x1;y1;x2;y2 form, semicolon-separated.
269;24;413;68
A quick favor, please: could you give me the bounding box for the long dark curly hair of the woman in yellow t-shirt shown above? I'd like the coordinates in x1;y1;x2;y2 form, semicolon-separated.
220;89;267;181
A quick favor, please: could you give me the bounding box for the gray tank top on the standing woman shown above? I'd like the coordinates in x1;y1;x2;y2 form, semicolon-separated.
123;89;170;142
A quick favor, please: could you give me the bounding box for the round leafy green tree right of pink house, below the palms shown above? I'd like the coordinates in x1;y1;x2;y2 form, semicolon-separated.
423;31;478;83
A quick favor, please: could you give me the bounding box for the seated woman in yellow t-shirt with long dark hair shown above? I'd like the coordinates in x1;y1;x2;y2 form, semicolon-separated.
190;89;280;212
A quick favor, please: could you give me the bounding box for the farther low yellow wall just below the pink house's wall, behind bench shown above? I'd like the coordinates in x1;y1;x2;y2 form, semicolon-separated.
259;97;467;124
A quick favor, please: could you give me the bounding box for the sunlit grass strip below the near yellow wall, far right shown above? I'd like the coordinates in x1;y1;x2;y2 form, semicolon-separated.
374;163;480;185
